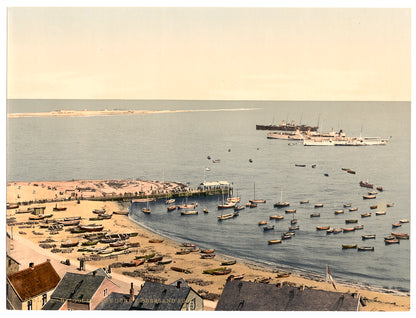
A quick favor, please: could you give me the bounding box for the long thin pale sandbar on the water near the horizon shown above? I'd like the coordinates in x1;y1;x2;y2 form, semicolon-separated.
7;108;261;118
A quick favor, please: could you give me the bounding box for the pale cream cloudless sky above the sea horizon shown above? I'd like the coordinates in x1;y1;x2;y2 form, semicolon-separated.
7;3;411;101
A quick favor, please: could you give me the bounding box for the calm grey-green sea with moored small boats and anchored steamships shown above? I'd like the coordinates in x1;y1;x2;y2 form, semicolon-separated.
7;100;410;292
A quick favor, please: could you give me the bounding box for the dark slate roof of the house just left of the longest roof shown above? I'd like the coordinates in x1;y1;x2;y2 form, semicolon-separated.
131;282;192;310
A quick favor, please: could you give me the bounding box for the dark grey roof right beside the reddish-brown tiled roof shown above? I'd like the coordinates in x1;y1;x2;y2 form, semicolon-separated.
51;273;106;303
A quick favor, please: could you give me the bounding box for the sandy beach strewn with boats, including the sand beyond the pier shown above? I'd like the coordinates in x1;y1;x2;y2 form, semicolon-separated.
7;181;410;311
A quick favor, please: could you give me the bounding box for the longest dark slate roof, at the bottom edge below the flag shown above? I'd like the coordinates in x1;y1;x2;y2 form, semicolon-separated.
215;280;359;311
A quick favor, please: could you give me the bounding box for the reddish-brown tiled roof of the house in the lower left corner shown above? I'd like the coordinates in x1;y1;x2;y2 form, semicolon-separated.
7;262;61;301
